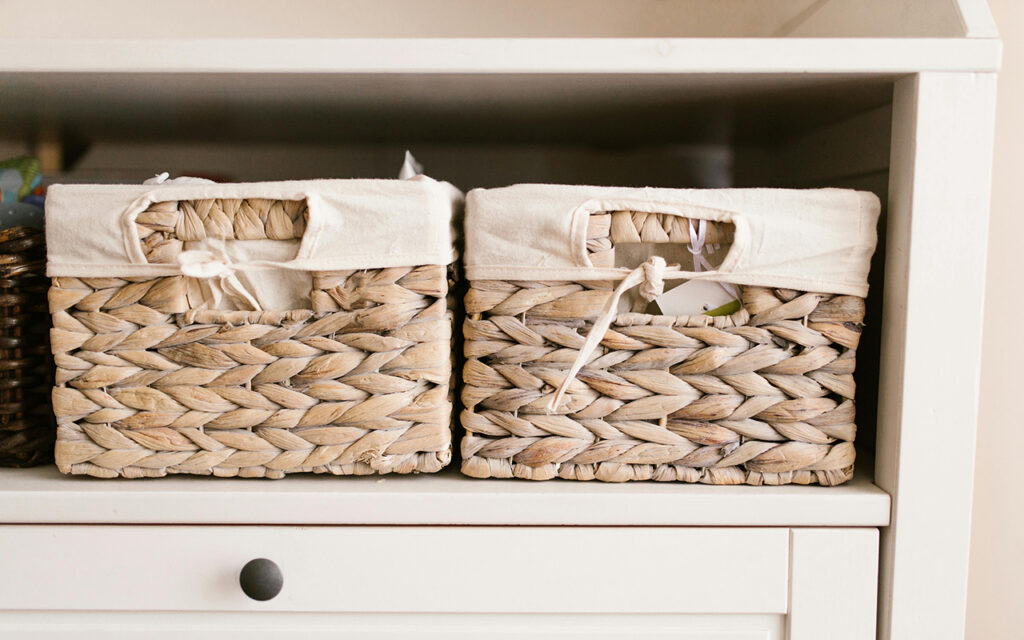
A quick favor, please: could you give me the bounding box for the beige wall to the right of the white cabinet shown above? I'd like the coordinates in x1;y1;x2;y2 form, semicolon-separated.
966;0;1024;640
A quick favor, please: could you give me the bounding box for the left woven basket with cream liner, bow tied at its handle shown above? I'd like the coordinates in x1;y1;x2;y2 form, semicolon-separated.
47;179;454;478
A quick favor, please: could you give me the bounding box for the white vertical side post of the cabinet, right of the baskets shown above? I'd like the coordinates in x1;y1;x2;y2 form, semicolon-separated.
876;73;995;640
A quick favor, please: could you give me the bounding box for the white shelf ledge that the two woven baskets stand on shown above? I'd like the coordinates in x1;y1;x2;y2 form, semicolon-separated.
0;462;890;526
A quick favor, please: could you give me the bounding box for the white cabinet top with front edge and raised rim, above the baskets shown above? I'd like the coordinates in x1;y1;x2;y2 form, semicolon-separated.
0;0;1000;75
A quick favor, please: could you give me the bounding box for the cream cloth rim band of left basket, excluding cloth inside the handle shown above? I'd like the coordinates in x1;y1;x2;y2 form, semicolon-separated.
46;176;462;278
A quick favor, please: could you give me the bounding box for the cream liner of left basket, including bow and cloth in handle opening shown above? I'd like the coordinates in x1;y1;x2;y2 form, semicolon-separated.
46;176;461;309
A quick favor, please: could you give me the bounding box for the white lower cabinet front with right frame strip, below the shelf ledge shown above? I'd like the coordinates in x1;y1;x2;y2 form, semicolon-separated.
0;525;878;639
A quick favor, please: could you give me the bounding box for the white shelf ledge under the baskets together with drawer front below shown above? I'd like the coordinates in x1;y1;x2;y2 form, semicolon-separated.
0;468;890;640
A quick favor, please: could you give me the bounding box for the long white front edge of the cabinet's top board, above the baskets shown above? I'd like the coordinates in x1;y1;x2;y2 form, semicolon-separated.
0;38;1001;74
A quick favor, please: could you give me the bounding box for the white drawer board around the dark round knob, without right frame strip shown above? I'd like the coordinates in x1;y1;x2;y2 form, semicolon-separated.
0;525;790;613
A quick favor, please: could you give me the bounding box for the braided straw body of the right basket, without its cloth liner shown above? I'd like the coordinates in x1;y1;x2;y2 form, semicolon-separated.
462;211;864;485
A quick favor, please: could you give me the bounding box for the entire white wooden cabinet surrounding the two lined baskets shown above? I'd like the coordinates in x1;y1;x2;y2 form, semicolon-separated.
0;0;1000;640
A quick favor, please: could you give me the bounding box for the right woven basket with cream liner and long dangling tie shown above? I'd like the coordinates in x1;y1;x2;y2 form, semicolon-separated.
462;185;879;485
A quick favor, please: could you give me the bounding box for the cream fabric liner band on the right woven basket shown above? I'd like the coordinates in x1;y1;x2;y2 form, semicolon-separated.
466;184;881;297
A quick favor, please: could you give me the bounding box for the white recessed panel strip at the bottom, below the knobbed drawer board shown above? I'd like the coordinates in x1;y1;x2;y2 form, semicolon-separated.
0;611;782;640
